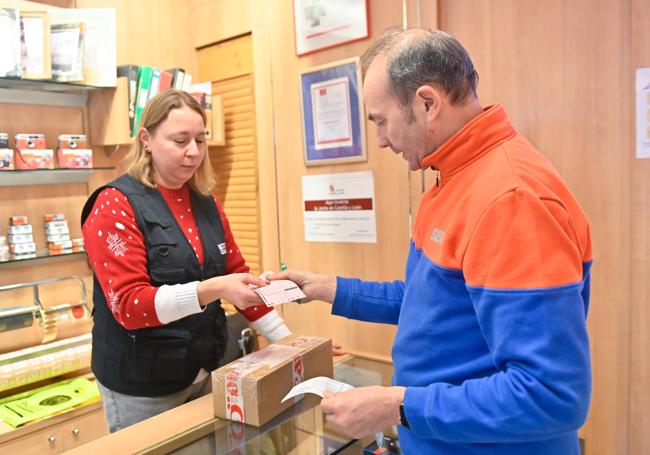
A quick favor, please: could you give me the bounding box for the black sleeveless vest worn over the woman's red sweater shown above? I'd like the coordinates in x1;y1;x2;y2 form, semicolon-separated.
81;175;228;397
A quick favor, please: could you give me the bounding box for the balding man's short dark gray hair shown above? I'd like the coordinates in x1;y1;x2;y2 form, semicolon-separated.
361;27;478;108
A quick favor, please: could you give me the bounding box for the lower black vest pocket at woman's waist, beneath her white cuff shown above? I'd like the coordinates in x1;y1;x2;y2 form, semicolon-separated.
120;328;192;385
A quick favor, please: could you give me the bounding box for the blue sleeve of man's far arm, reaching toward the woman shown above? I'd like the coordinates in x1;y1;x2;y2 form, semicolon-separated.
332;277;404;324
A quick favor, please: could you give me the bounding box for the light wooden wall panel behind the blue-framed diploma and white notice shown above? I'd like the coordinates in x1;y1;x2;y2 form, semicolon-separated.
253;0;410;354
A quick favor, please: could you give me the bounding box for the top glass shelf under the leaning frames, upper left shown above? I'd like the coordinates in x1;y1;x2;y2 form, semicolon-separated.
0;77;110;107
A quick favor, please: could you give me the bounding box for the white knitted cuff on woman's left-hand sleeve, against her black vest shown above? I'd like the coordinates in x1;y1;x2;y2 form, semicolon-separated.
154;281;203;324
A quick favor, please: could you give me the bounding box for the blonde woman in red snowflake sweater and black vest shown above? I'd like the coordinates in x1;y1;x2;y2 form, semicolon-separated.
82;90;291;432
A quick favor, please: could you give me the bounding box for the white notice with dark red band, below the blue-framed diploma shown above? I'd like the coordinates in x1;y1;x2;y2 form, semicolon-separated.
302;171;377;243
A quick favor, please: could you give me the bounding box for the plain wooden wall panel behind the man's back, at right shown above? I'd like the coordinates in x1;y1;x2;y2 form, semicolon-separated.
439;0;636;454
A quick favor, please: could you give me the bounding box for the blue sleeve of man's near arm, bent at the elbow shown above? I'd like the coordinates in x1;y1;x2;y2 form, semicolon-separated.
404;283;591;443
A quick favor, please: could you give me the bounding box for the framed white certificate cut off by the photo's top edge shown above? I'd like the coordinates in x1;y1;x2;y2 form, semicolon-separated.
293;0;370;55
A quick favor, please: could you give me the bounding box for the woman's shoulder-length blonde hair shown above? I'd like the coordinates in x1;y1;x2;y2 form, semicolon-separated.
124;89;215;196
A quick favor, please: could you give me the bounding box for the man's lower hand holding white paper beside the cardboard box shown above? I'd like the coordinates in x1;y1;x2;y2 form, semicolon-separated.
320;386;406;439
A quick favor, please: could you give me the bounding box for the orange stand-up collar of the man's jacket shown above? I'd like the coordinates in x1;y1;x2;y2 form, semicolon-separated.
422;104;517;178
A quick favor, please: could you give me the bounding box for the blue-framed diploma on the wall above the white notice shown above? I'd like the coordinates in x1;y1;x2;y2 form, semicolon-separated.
299;57;367;166
